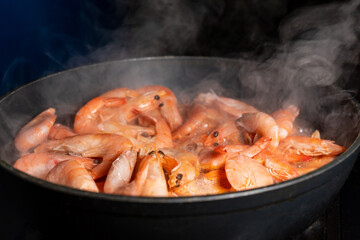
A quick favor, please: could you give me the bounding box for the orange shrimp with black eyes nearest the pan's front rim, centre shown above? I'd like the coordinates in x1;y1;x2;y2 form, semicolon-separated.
161;148;200;188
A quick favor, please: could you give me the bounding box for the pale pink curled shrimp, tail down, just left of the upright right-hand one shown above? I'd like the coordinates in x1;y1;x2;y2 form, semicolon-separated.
236;112;280;150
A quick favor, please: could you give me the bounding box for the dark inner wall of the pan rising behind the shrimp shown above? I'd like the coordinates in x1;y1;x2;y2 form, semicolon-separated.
0;57;360;201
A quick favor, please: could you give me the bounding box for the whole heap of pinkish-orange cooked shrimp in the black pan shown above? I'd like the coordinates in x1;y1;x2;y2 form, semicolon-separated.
14;85;345;197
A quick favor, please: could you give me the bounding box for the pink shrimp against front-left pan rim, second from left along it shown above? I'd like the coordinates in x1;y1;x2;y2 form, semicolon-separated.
46;158;99;192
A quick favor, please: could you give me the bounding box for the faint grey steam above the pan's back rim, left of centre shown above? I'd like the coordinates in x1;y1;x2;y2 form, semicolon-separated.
68;0;208;66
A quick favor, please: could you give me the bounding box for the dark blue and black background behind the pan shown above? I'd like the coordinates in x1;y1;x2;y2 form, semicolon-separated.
0;0;360;239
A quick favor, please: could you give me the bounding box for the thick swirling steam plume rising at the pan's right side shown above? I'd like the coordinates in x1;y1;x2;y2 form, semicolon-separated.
236;1;360;107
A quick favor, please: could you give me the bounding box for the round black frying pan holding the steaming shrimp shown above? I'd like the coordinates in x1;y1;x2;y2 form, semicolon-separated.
0;57;360;239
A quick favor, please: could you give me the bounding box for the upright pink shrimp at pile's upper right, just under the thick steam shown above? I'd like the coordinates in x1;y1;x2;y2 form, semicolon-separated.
271;105;299;140
